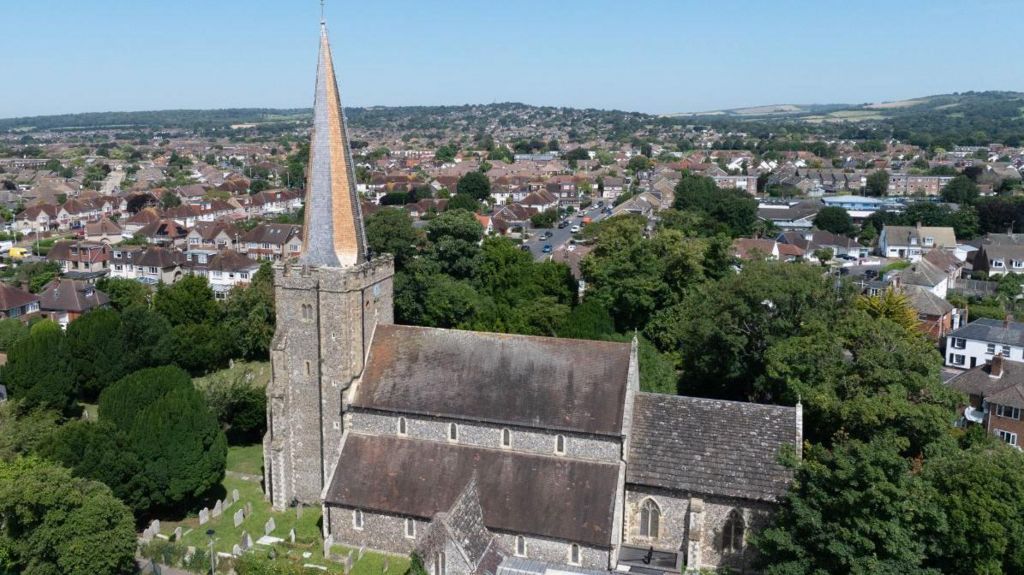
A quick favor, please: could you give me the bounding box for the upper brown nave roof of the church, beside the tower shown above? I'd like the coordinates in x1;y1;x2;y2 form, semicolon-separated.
352;325;631;436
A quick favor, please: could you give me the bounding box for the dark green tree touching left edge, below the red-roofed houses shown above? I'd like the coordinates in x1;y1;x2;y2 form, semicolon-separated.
0;321;78;416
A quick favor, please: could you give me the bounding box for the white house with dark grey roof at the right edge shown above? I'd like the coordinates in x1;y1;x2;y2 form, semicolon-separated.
945;317;1024;369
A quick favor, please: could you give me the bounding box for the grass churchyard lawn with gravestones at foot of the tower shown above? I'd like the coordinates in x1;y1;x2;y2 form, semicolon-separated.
161;444;409;575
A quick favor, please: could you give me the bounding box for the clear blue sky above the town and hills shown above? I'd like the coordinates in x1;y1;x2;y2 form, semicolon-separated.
0;0;1024;118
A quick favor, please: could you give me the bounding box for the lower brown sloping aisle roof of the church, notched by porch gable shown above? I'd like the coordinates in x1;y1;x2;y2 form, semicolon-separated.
325;434;618;548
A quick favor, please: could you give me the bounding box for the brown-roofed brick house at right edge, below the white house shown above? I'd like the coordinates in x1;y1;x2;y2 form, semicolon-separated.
949;354;1024;449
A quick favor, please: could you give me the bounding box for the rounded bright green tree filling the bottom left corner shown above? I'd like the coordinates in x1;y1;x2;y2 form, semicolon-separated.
0;458;135;575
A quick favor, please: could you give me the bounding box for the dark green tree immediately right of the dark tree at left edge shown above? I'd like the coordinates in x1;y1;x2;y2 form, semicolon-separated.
68;309;128;401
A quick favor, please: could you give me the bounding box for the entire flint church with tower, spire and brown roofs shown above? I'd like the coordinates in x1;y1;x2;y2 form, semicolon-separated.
263;14;803;575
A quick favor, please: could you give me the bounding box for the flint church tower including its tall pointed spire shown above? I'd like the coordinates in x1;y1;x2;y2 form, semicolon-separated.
263;17;394;510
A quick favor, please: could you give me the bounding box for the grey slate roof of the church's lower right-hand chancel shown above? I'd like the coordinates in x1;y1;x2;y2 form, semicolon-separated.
626;393;799;501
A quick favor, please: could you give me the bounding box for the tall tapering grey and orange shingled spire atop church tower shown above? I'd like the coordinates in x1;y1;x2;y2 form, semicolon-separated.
299;10;367;267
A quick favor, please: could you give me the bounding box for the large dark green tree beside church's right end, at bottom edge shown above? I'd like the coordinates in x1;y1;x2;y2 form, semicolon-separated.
753;438;943;575
